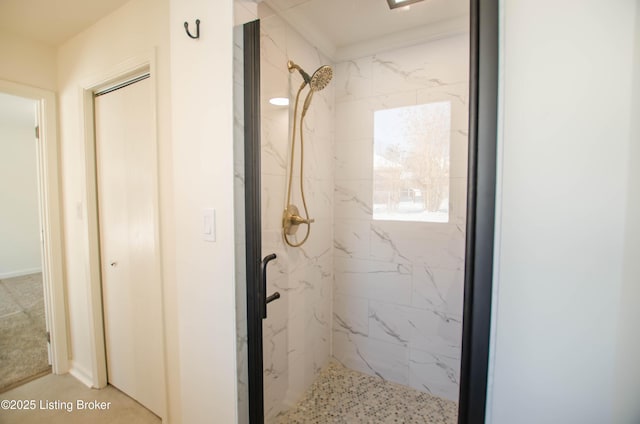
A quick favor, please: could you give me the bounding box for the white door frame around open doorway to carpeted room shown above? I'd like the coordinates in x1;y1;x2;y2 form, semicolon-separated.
0;80;69;374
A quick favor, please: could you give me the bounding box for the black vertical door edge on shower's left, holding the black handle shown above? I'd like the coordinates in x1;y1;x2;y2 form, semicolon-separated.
243;20;264;424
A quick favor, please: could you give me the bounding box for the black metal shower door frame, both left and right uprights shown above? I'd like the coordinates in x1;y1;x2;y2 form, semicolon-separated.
243;0;499;424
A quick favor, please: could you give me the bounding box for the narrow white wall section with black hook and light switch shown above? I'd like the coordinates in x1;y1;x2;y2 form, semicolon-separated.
169;0;237;423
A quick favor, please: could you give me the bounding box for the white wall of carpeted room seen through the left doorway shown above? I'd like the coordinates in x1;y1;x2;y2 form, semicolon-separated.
0;93;42;279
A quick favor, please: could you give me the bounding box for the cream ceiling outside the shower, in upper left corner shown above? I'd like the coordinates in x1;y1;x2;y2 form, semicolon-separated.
0;0;129;46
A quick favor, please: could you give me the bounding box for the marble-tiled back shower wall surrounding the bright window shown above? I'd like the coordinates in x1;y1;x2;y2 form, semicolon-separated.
332;35;469;400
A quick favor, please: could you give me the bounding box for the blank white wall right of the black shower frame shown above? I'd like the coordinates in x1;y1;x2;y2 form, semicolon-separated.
488;0;640;424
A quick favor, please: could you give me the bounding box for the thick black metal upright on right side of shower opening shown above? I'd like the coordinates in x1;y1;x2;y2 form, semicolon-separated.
458;0;498;424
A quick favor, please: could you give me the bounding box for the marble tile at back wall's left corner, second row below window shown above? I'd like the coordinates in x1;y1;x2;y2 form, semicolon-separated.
334;257;411;305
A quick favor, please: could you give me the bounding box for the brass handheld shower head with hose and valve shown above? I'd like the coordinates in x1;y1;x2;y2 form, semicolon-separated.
282;60;333;247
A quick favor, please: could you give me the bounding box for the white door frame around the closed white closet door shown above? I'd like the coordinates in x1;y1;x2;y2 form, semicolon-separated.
78;50;168;421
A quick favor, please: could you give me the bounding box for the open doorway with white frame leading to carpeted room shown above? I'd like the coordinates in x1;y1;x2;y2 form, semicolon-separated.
0;81;68;391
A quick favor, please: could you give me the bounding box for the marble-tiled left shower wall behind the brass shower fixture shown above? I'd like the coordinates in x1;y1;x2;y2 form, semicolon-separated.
261;15;334;422
